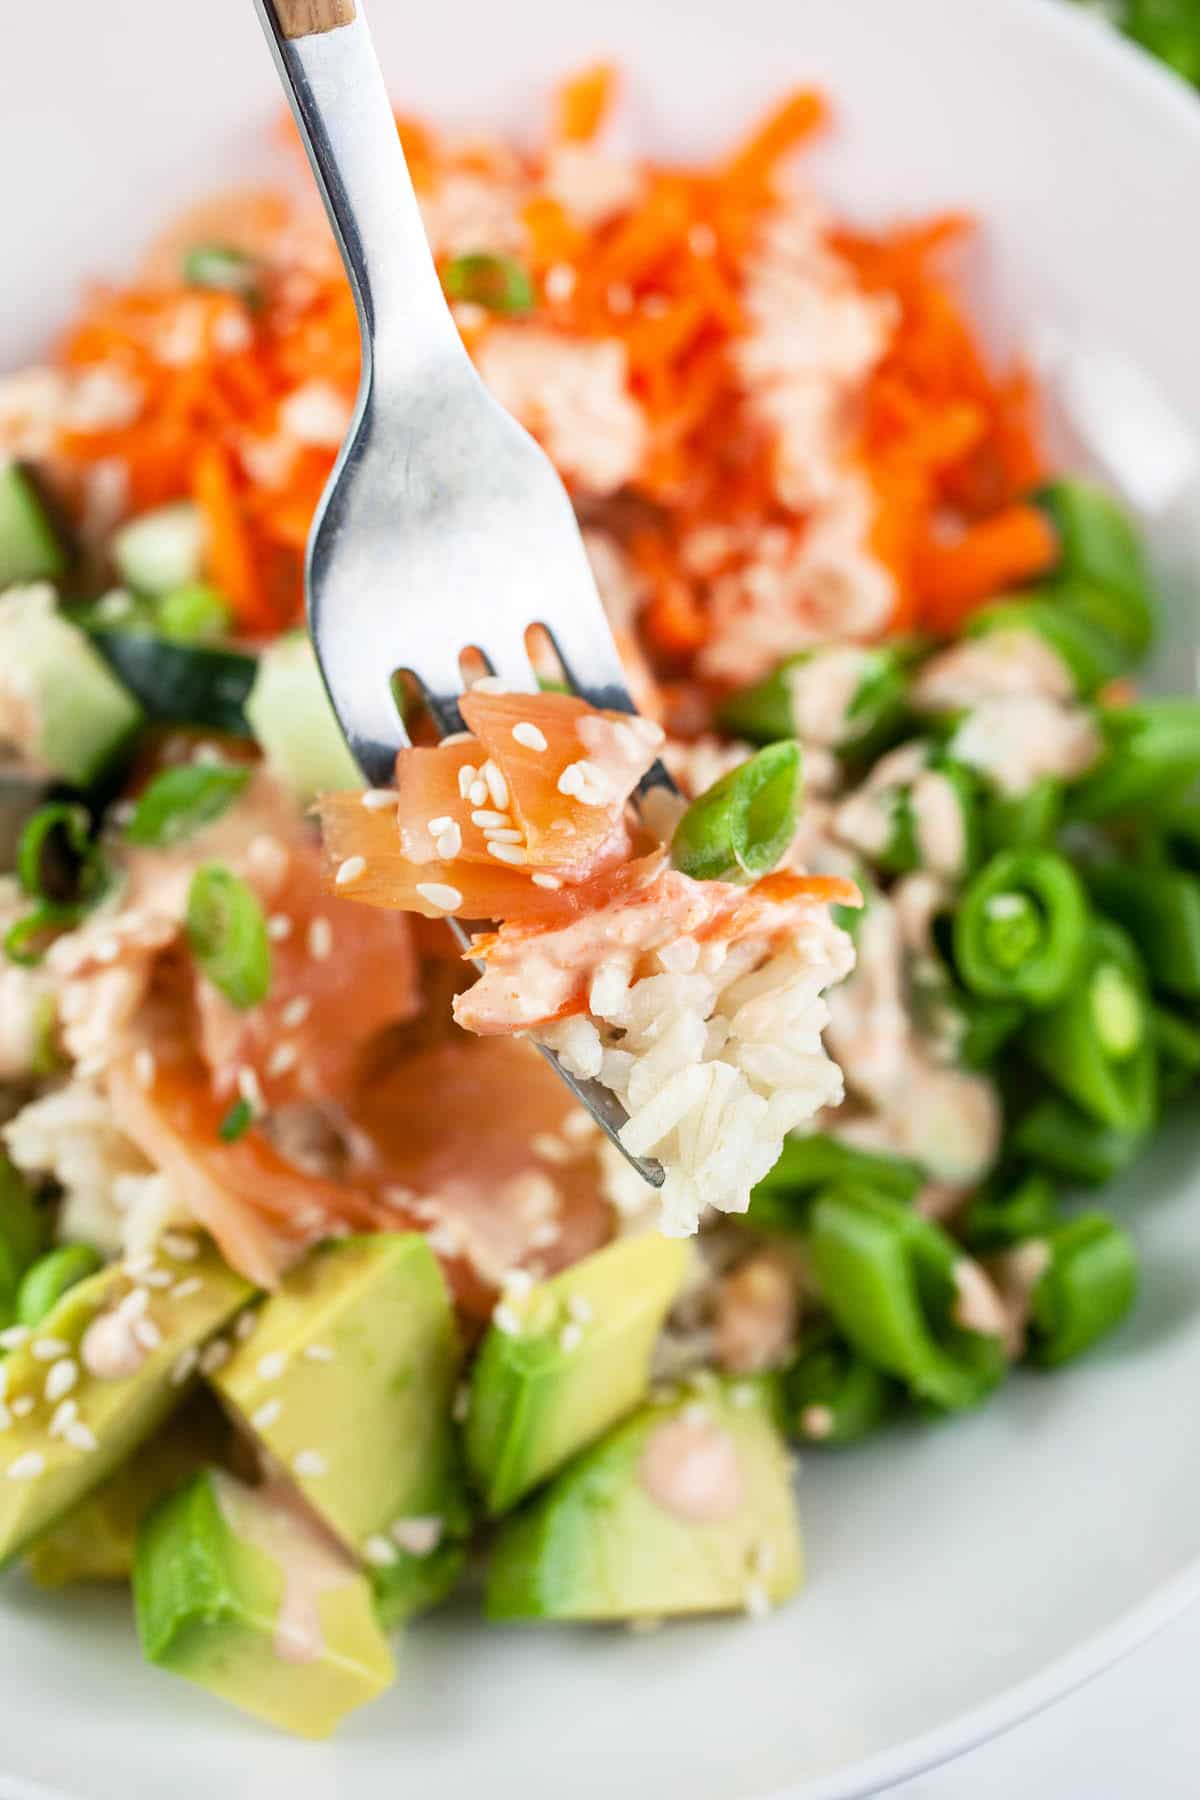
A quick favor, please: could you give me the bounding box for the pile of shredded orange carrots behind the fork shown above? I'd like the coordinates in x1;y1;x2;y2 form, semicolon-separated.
44;65;1052;673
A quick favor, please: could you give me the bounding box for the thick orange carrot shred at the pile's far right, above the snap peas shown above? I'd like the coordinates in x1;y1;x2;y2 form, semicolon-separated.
916;506;1060;634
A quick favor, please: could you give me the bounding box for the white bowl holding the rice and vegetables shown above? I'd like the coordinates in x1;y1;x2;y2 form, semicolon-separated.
0;0;1200;1800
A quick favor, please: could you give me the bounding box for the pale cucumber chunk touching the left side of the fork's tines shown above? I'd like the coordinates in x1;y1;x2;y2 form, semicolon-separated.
246;632;363;803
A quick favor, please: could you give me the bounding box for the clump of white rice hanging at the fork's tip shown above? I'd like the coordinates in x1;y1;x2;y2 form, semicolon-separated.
543;913;853;1237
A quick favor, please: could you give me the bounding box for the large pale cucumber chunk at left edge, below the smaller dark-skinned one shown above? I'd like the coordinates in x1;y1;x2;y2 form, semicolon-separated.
0;581;142;787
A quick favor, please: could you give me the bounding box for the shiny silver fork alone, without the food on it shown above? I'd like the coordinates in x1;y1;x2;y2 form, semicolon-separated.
254;0;669;1186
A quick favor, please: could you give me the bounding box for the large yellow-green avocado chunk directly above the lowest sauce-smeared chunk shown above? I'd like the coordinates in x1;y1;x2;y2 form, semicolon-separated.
212;1231;466;1566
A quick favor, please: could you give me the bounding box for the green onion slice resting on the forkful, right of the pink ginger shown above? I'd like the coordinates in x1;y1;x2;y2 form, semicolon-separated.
671;740;804;882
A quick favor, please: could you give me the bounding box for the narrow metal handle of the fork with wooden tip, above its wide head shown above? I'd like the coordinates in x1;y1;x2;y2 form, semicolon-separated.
254;0;459;382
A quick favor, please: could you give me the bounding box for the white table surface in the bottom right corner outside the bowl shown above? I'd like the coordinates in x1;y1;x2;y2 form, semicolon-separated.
887;1607;1200;1800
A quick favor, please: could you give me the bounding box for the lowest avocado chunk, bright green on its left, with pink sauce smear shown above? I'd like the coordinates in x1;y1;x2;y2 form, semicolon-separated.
133;1469;396;1737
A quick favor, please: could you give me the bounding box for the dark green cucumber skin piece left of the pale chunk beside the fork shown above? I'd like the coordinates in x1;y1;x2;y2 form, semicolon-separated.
92;630;257;738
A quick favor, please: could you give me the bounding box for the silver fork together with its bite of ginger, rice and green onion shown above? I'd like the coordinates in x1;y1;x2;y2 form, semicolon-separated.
255;0;858;1231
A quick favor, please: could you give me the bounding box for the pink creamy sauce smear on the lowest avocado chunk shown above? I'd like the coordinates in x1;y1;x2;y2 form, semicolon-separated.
212;1474;356;1663
